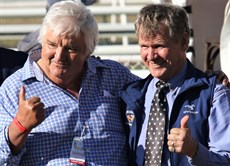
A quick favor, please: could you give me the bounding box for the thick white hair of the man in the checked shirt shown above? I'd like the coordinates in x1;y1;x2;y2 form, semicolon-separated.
38;0;98;53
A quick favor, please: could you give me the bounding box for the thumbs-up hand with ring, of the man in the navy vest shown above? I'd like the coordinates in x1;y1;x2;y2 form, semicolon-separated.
167;115;198;157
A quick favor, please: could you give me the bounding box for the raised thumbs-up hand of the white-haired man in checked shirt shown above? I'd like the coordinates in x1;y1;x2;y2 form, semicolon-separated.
16;86;45;130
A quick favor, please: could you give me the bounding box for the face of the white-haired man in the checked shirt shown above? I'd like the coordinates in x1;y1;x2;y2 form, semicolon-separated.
39;30;89;84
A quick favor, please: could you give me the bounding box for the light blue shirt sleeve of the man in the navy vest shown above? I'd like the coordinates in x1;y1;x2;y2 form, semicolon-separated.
189;83;230;166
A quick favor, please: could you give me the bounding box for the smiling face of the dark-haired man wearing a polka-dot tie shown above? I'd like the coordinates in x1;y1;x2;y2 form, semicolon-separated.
138;30;188;81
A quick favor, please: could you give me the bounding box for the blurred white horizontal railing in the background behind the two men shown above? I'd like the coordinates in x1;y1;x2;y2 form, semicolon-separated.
0;0;193;77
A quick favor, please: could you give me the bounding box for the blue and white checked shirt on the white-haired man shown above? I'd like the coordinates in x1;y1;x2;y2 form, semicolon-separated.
0;52;139;166
